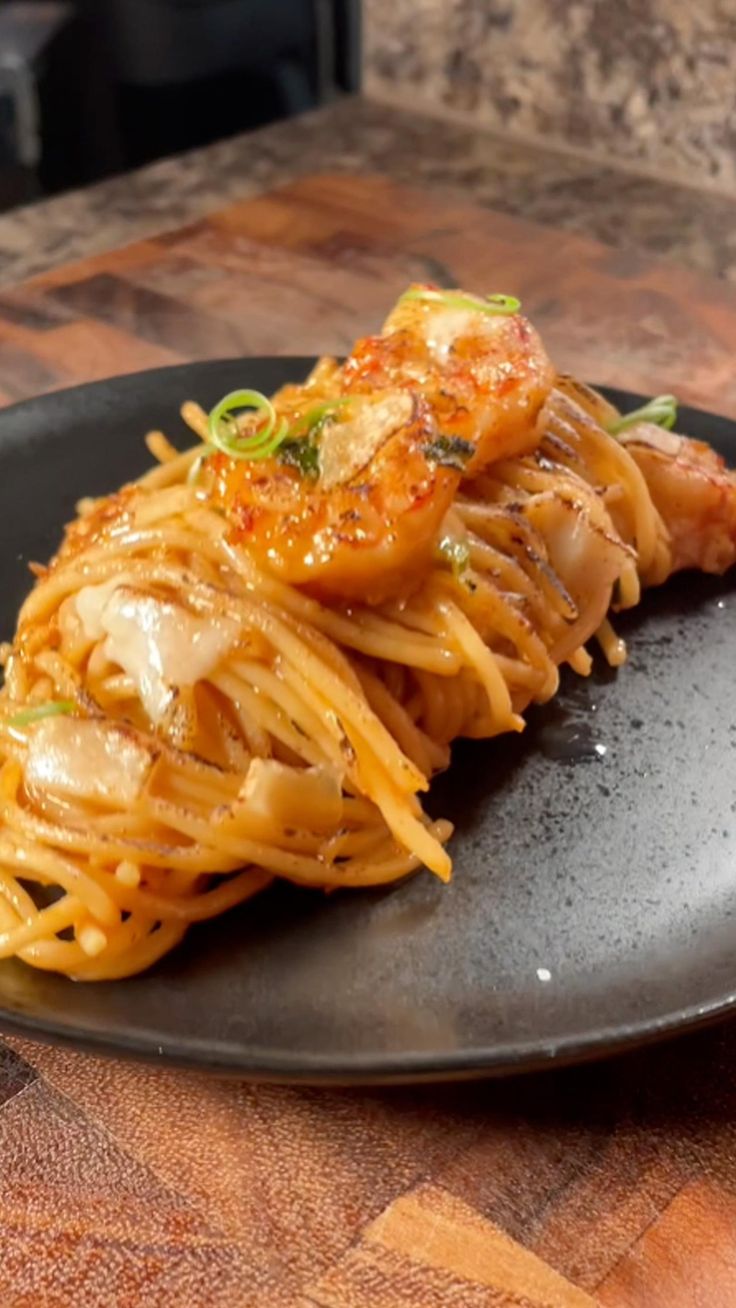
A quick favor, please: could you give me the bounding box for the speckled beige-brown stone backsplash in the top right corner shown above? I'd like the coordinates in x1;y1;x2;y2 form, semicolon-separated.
363;0;736;194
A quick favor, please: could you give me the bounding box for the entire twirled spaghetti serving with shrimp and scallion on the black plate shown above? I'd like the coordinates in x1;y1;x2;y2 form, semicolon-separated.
0;285;736;980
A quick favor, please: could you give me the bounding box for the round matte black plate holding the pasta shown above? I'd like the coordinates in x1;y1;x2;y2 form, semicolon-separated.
0;360;736;1082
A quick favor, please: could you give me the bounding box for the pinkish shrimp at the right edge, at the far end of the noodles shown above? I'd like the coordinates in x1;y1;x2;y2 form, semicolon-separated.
618;422;736;582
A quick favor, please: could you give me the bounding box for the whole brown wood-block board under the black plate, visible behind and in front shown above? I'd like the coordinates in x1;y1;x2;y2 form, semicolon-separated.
0;177;736;1308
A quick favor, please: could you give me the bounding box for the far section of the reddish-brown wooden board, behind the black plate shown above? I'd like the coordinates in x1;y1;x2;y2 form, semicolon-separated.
0;177;736;413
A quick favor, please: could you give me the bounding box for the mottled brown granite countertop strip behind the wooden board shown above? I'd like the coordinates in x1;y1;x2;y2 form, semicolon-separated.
0;97;736;285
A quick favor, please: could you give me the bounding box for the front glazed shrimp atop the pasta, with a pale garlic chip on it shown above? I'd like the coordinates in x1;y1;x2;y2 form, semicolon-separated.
213;392;459;603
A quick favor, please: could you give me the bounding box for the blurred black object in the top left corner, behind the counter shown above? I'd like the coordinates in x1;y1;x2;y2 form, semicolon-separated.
0;0;360;211
